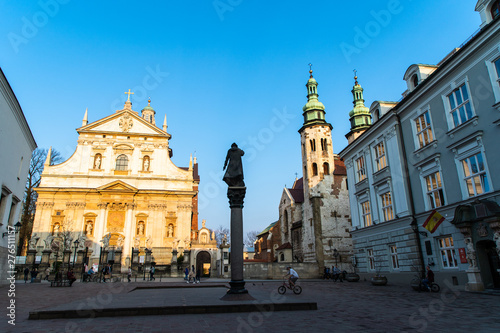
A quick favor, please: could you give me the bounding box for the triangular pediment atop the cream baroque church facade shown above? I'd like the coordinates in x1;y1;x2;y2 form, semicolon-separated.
77;110;169;136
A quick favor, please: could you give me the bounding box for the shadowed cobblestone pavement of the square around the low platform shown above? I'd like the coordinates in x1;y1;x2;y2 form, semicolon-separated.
0;279;500;333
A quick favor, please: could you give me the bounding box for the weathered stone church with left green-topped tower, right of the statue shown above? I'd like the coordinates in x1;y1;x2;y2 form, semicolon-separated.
255;70;352;272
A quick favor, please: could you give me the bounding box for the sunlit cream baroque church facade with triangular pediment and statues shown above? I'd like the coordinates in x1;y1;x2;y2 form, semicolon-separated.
30;91;217;270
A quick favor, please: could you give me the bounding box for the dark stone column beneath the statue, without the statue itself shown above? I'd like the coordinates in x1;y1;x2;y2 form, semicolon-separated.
221;186;254;301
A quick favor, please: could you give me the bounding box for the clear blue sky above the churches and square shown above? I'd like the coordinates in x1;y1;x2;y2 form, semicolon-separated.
0;0;480;231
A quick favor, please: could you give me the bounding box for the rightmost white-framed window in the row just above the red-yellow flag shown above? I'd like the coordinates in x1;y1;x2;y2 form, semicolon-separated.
462;153;490;197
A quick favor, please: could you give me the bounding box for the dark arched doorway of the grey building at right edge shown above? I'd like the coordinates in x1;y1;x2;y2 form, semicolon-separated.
476;240;500;289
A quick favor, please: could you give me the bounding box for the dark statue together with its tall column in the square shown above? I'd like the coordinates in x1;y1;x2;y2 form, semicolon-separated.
221;143;254;301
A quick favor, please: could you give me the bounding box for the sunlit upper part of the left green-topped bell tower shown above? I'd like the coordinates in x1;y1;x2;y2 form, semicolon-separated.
299;65;335;189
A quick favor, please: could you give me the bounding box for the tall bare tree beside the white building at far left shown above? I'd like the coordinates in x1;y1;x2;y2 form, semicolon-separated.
18;148;64;255
